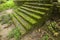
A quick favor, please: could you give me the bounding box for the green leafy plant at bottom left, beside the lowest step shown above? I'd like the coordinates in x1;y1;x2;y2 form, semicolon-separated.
8;27;21;40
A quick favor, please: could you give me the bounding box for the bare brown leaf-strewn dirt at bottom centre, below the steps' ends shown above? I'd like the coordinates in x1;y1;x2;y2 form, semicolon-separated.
21;28;47;40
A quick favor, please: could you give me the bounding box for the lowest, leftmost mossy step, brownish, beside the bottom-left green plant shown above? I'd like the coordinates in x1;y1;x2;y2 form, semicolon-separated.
10;14;26;35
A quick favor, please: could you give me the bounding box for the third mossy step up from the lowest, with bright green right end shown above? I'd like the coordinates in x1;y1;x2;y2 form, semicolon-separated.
15;9;37;24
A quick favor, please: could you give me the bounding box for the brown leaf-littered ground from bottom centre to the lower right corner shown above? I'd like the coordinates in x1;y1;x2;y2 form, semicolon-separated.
21;19;60;40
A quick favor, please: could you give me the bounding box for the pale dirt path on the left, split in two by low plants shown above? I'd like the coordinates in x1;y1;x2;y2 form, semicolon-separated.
0;9;14;40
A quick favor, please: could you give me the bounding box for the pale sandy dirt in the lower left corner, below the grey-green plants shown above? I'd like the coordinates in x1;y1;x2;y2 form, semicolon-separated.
0;24;14;40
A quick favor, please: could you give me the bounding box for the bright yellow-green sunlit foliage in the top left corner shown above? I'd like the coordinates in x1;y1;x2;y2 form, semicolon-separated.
0;1;15;11
